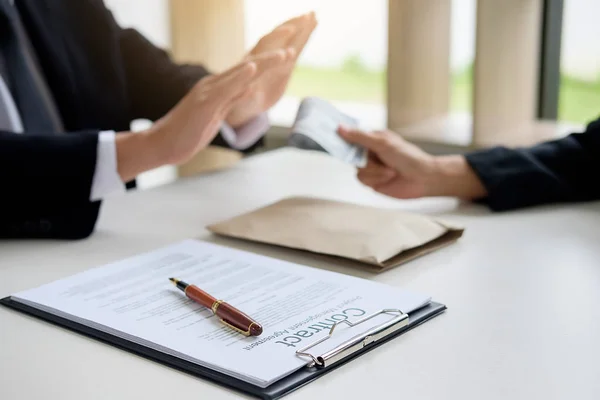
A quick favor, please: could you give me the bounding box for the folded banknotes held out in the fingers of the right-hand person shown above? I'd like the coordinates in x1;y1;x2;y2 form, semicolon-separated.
290;97;367;167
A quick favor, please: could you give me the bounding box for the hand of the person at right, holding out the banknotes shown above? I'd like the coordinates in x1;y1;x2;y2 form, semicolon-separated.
338;127;487;199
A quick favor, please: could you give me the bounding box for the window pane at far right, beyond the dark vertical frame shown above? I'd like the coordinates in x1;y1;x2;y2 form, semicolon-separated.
558;0;600;124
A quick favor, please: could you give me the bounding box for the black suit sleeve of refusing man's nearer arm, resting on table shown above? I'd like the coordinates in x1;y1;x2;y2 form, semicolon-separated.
0;131;100;239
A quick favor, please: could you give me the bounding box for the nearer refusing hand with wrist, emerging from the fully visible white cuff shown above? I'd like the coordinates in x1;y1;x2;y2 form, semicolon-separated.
116;52;283;182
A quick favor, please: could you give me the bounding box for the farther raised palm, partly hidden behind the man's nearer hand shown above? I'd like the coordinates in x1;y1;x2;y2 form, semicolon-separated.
226;12;317;128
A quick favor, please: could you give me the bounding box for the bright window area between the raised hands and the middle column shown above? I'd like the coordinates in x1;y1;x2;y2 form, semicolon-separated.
245;0;388;127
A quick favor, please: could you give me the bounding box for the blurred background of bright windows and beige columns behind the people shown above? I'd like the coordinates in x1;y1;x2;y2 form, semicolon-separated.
105;0;600;184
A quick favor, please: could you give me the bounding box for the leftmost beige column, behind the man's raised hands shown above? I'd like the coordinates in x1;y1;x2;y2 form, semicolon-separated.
170;0;245;177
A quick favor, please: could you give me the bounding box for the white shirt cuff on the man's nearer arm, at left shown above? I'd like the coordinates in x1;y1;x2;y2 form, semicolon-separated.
90;131;125;201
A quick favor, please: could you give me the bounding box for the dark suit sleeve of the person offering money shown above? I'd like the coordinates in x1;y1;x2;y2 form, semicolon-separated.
466;119;600;211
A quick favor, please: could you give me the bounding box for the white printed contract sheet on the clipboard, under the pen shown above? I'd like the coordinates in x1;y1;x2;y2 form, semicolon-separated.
12;240;430;387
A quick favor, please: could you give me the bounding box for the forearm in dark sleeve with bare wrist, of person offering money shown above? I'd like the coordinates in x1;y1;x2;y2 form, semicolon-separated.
427;116;600;211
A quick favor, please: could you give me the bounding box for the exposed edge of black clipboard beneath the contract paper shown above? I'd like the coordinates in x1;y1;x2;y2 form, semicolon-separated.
0;297;446;400
